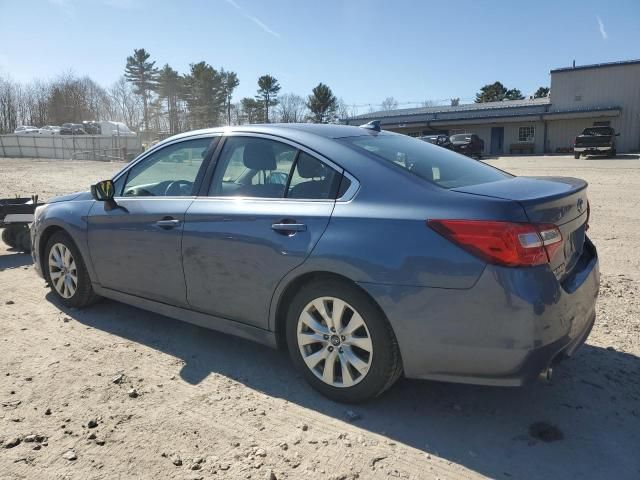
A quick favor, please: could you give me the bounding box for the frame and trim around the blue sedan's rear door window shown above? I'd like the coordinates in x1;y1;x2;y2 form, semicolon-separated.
195;131;360;203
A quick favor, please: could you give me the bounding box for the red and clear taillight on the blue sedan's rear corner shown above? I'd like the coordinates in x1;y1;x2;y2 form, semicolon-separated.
427;220;562;267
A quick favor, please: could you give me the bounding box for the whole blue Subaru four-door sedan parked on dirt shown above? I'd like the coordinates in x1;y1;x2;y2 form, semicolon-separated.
32;124;599;402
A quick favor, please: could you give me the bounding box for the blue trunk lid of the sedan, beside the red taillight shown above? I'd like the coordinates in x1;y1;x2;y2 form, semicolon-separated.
452;177;587;281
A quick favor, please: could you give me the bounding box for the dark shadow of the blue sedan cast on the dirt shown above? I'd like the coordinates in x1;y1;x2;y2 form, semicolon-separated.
56;294;640;479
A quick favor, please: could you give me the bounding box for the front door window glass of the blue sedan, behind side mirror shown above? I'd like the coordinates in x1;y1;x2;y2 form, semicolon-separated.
121;138;212;197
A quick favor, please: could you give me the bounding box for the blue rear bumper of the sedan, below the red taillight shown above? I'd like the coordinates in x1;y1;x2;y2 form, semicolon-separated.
361;240;599;386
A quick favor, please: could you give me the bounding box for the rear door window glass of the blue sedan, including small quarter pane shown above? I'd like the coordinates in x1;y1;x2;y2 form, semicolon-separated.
209;136;341;199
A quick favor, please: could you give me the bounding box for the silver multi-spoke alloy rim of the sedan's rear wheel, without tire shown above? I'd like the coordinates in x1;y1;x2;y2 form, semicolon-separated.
297;297;373;387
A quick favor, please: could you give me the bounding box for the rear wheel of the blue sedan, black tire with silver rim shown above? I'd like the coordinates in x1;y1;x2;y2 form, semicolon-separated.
286;280;402;403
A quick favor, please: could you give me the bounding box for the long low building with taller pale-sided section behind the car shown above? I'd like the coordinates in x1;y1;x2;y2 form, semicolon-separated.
345;60;640;155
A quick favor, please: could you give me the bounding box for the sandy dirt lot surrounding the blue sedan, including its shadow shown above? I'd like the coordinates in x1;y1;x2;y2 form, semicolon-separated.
0;155;640;479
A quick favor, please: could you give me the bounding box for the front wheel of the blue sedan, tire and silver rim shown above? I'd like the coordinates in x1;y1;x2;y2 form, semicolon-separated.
43;231;100;308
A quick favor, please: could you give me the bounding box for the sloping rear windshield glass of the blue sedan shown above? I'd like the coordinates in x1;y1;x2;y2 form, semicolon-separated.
342;135;512;188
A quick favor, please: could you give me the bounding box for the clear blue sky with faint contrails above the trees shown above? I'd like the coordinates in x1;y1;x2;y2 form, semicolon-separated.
0;0;640;106
